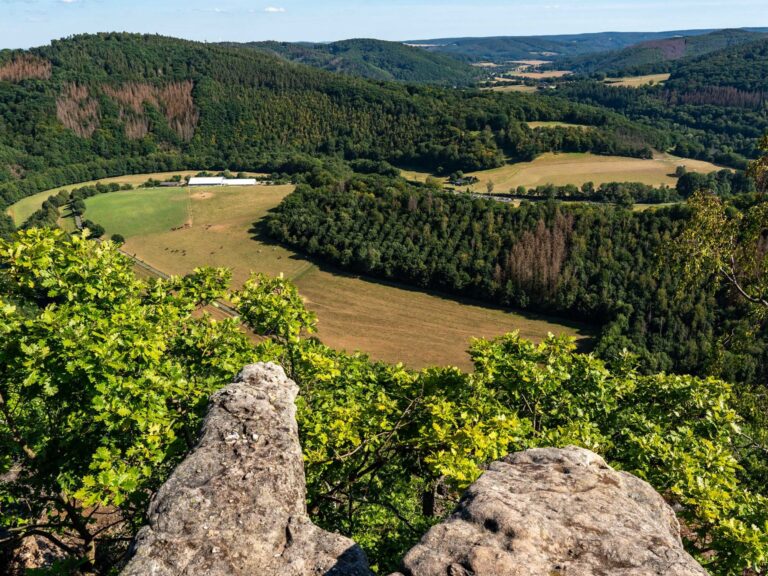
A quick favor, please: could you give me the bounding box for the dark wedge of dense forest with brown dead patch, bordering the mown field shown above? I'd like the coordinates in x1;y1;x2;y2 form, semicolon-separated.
266;176;768;381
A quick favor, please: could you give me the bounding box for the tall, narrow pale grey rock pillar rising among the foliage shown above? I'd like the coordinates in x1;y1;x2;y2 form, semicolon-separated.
122;364;371;576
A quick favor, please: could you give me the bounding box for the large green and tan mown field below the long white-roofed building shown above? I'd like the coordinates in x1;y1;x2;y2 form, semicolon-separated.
63;186;589;368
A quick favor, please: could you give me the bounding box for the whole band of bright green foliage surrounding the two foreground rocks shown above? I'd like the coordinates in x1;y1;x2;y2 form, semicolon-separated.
0;229;768;576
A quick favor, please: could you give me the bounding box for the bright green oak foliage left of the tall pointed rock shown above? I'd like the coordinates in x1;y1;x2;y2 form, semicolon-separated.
0;229;258;566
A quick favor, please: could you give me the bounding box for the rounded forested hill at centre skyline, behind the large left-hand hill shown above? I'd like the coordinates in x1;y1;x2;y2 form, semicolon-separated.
226;39;478;86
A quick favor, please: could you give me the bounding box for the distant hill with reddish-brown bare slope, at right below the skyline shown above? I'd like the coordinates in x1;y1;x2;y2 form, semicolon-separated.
558;29;768;76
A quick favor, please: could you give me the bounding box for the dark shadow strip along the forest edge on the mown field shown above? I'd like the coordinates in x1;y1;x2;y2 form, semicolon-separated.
248;210;600;353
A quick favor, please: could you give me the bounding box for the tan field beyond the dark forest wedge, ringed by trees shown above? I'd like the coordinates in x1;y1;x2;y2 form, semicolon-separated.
402;153;721;193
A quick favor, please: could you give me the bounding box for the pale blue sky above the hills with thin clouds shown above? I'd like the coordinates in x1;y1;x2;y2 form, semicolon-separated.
0;0;768;48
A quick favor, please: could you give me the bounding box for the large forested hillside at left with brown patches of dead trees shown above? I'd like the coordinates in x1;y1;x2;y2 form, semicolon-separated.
0;33;669;210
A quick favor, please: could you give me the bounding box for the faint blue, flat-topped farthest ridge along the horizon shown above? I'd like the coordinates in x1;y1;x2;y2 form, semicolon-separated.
408;28;768;62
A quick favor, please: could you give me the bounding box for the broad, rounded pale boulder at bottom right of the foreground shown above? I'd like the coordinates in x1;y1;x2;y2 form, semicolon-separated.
392;447;706;576
